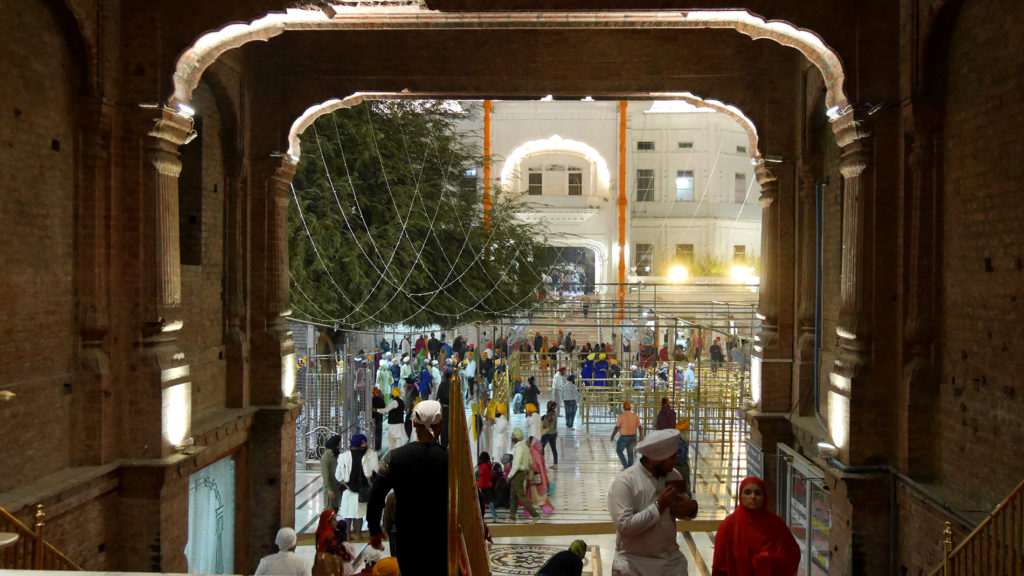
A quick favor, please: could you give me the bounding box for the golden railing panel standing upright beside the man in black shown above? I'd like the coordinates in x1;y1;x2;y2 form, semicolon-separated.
447;368;490;576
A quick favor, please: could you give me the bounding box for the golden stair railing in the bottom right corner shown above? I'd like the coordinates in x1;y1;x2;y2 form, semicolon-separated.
932;475;1024;576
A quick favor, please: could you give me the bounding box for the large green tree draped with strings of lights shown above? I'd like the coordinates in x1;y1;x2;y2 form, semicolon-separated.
288;101;548;328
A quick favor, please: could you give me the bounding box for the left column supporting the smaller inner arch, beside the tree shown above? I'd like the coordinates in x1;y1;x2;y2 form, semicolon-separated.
251;157;295;406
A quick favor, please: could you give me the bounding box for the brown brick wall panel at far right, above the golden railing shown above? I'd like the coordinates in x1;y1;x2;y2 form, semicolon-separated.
935;0;1024;509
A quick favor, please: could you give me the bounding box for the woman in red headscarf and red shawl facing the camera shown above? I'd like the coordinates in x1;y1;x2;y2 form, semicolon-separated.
712;476;800;576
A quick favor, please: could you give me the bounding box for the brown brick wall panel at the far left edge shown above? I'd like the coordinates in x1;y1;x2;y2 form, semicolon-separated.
0;1;77;492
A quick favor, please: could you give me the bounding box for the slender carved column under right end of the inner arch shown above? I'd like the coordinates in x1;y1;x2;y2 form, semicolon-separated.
755;161;778;351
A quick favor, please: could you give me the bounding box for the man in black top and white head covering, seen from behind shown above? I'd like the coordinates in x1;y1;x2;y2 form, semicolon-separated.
367;400;449;576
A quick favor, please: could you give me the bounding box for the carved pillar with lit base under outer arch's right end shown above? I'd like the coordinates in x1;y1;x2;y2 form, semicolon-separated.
827;111;873;460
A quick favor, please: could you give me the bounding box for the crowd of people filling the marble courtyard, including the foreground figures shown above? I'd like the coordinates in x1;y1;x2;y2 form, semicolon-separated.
257;331;786;576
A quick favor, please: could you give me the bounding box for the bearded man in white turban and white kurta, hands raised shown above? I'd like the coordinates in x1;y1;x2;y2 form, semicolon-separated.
608;429;696;576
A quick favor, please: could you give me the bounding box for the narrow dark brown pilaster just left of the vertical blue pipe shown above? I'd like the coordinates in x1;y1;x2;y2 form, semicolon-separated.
797;157;820;415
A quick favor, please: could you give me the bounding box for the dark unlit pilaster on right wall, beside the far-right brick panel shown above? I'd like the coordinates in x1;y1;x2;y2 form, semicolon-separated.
899;123;939;476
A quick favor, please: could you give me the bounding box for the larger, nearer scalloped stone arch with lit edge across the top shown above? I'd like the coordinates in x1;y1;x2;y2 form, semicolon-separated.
169;6;852;129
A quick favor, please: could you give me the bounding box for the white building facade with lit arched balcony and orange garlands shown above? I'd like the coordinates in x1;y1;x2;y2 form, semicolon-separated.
464;100;761;294
